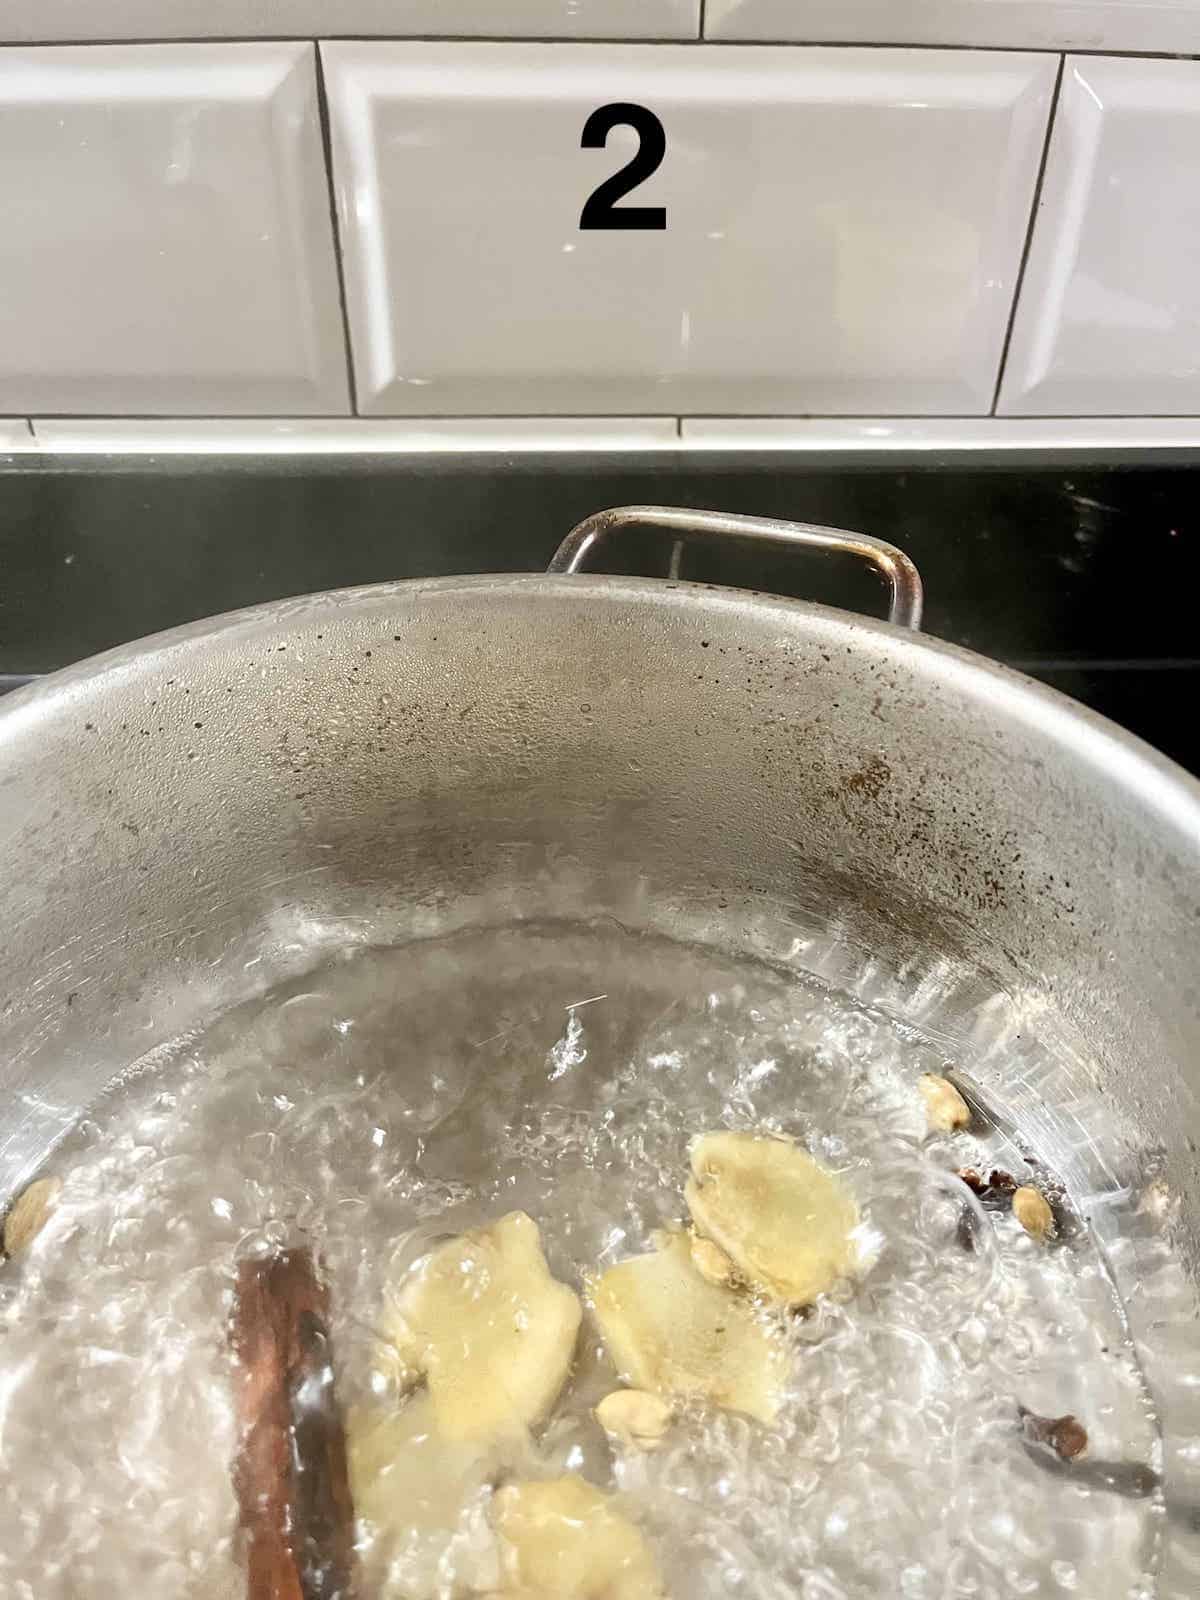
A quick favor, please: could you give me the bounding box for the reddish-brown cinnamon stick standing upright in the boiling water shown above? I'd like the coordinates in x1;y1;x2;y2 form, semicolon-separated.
230;1250;354;1600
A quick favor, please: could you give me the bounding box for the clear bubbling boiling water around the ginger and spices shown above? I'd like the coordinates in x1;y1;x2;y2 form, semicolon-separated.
0;928;1162;1600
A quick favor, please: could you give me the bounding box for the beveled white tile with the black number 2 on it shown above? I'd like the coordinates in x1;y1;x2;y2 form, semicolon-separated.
322;43;1056;416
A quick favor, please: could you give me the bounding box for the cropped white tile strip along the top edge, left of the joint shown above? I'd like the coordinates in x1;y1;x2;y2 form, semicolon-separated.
0;0;701;43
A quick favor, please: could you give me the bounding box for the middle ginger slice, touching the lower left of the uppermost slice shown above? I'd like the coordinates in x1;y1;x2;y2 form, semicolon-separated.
592;1232;786;1422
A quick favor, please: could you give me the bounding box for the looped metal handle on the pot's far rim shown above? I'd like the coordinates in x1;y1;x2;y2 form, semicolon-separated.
546;506;925;629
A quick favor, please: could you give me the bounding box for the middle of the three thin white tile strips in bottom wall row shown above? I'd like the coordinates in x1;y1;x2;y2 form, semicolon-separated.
34;416;678;456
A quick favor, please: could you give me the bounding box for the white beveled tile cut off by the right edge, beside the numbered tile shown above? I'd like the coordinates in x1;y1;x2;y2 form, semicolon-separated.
1000;56;1200;416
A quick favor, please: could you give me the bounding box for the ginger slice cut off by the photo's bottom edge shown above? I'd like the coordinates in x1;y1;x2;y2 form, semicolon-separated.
493;1477;666;1600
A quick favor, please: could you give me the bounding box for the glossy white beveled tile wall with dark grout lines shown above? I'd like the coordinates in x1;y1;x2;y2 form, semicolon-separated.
0;0;1200;453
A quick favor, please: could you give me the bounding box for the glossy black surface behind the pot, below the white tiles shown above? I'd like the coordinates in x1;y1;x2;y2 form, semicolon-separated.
0;454;1200;771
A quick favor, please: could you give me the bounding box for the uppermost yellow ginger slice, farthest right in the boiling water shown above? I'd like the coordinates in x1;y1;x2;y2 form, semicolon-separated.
685;1133;859;1306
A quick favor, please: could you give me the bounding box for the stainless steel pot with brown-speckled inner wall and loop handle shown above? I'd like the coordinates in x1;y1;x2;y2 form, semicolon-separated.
0;507;1200;1600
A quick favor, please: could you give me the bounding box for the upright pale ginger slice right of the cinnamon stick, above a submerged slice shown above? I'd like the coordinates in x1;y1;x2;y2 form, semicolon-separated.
384;1211;581;1443
